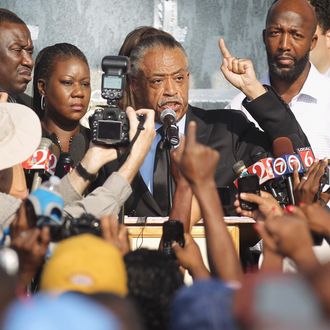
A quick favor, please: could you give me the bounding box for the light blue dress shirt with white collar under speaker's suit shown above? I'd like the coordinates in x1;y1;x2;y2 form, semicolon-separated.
140;115;186;193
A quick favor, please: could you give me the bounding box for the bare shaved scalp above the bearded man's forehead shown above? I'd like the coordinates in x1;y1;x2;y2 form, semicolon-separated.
266;0;317;36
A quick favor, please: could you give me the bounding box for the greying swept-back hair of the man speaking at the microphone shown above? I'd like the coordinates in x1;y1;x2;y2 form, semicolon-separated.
130;34;187;77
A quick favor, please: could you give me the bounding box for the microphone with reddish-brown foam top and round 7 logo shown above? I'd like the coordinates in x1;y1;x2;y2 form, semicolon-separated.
273;137;303;205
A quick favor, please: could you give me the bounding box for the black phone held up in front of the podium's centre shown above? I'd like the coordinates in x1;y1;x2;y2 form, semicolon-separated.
162;220;184;258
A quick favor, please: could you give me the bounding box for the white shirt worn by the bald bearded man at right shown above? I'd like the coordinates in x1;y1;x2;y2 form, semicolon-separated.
226;64;330;159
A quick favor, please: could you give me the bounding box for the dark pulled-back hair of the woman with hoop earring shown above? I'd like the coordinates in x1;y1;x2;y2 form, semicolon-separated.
33;43;88;119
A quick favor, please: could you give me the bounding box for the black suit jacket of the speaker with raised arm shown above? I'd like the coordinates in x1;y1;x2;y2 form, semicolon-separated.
99;90;309;216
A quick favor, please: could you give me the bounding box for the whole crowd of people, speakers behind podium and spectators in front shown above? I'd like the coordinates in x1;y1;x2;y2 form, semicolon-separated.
0;0;330;330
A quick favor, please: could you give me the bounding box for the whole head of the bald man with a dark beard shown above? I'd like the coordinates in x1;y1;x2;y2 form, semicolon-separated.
263;0;317;84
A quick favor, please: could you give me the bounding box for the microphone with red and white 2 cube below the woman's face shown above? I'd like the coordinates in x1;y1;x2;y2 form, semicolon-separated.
22;137;60;191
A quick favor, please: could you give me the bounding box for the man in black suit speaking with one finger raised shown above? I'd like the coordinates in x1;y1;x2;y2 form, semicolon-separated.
101;30;308;216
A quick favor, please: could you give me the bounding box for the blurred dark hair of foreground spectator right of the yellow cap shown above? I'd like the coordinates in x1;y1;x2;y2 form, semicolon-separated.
124;249;183;330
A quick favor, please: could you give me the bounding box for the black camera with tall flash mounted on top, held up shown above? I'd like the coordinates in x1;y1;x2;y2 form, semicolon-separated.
89;56;129;146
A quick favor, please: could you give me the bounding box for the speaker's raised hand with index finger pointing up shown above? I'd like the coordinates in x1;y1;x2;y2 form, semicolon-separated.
219;38;266;100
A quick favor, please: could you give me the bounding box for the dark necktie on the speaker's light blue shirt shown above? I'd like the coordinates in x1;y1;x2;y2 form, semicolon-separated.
153;127;169;216
